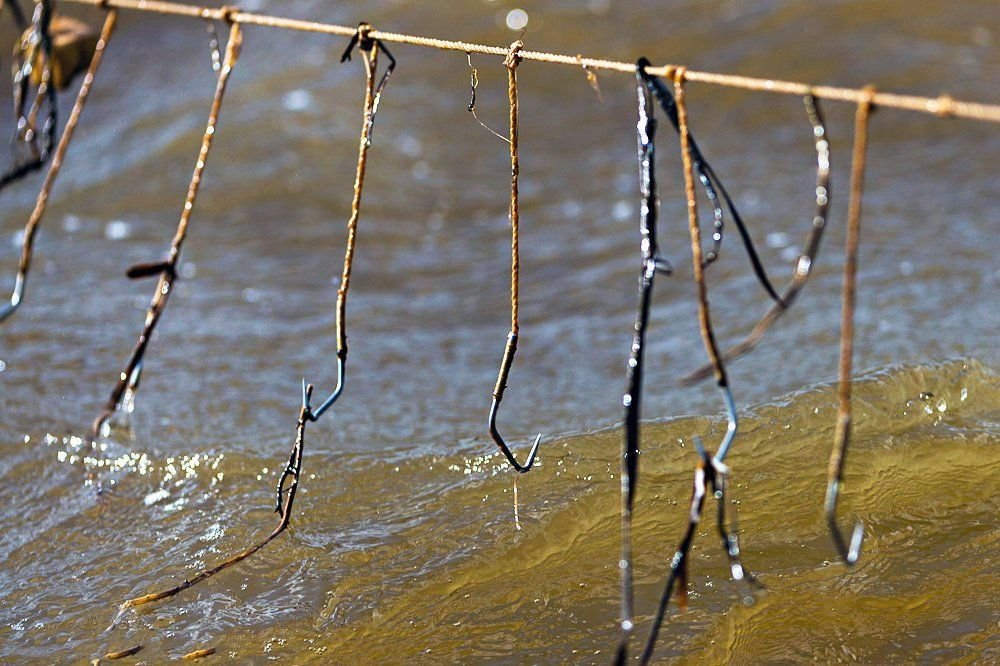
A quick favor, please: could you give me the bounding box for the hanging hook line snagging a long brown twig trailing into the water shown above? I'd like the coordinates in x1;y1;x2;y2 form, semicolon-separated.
115;23;396;629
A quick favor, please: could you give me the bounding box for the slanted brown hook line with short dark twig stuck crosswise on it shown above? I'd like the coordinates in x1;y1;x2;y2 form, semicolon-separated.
91;15;243;437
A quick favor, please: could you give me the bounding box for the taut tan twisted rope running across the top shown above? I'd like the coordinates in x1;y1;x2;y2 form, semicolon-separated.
62;0;1000;123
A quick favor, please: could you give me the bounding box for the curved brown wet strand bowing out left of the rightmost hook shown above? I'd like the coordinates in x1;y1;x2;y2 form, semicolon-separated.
680;95;830;386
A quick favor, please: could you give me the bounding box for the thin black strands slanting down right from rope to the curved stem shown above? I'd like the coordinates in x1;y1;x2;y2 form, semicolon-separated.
638;58;782;303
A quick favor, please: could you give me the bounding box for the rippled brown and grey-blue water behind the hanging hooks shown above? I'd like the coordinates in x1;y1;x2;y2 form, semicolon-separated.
0;0;1000;663
